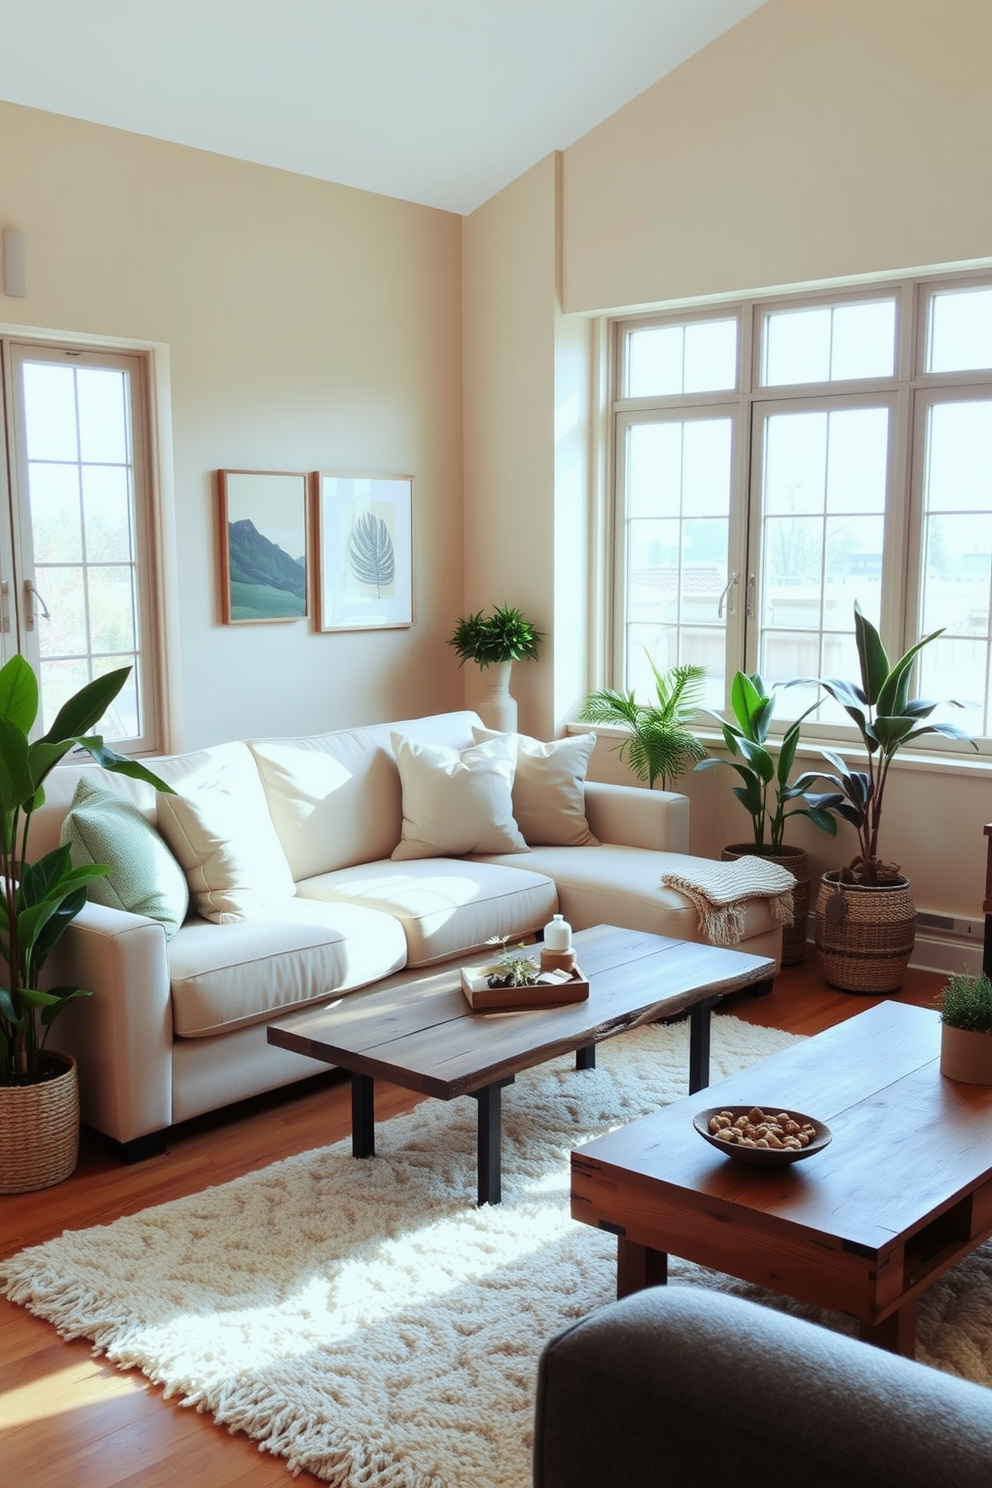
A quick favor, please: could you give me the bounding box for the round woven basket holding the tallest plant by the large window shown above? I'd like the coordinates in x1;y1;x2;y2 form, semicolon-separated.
815;872;916;994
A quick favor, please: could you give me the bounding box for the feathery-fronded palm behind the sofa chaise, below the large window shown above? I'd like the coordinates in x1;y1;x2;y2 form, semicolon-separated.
579;652;706;790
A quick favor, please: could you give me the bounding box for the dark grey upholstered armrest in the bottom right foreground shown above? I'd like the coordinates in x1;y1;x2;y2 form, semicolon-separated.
534;1286;992;1488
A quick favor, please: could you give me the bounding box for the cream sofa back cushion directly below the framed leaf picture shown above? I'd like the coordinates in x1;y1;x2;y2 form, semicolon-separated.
250;711;479;881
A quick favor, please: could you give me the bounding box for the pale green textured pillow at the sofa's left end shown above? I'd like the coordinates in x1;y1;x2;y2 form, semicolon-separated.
61;777;189;940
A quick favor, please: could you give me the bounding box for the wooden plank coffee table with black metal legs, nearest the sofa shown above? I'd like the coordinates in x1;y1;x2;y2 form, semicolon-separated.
268;926;775;1204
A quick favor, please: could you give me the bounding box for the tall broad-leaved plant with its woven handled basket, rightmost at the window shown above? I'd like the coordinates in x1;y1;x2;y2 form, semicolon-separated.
787;601;977;992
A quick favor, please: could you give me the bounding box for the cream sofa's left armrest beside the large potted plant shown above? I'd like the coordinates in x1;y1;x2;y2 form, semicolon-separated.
45;903;173;1143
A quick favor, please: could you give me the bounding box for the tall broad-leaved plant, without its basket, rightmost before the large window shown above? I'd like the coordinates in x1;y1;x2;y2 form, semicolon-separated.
787;601;977;887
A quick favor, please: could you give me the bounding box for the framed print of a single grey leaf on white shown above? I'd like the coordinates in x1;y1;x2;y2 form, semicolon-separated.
314;470;413;631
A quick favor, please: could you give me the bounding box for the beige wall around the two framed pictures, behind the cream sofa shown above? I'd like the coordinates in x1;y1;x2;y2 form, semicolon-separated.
0;104;463;747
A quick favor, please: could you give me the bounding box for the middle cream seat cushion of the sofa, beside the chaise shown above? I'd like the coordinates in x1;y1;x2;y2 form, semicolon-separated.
297;856;558;966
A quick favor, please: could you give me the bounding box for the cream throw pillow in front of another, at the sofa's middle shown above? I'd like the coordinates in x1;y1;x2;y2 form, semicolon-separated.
391;734;528;860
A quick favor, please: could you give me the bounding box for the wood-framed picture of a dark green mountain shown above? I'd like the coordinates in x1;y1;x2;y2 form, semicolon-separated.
217;470;309;625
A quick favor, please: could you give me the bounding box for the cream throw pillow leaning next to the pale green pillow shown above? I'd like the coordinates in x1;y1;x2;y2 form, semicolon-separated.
158;744;294;924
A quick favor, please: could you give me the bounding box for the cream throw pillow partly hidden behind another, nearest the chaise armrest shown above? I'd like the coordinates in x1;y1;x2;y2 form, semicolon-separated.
471;728;599;847
